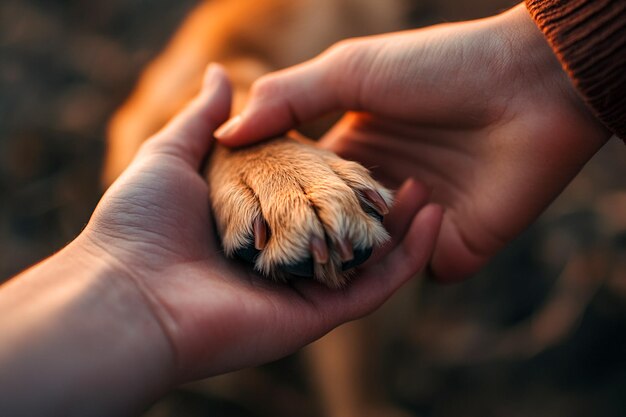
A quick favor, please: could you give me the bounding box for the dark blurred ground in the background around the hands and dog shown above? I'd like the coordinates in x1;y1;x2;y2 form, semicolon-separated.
0;0;626;417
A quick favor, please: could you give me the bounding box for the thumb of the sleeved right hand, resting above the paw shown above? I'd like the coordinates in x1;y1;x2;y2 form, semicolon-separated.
215;43;362;146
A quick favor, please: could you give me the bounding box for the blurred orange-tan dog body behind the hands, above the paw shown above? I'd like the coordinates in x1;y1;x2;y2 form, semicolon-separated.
104;0;404;184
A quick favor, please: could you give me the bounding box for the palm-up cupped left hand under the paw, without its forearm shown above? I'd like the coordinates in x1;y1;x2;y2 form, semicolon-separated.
79;65;441;382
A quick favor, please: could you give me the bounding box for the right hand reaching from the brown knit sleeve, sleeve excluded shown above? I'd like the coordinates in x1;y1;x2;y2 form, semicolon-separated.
216;5;610;281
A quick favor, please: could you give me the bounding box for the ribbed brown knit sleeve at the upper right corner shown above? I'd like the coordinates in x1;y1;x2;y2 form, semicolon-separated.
526;0;626;139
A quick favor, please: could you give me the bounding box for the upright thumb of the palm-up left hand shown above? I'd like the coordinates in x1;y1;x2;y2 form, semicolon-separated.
142;64;232;170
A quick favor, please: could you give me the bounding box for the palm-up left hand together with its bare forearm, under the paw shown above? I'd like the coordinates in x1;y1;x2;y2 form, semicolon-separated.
0;66;442;416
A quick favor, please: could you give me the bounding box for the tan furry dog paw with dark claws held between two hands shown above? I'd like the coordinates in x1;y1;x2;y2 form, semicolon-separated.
207;138;392;288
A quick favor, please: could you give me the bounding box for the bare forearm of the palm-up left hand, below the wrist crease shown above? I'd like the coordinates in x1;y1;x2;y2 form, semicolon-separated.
0;237;172;416
